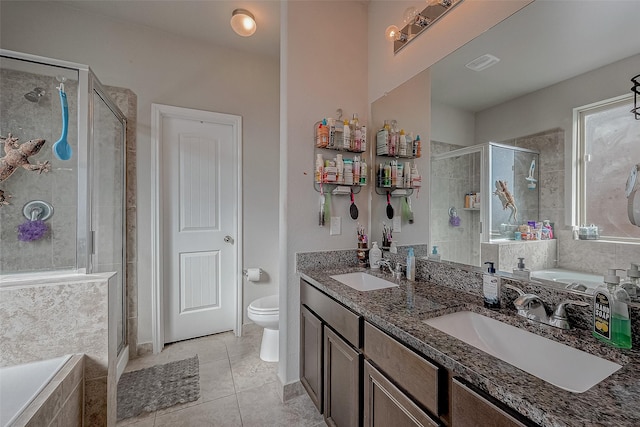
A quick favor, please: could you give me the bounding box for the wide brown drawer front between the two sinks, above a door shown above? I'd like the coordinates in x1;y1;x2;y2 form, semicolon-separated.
364;322;446;416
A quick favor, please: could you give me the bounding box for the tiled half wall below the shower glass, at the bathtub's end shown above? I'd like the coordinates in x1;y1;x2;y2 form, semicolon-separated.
0;273;117;426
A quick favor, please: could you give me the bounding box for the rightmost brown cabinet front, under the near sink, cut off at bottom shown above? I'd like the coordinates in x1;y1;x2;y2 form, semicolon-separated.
451;378;536;427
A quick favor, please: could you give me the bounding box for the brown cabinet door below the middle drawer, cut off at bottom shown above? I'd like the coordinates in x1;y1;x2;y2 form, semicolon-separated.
364;361;441;427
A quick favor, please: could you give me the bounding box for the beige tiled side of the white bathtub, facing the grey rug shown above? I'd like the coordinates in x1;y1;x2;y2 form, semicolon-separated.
13;354;84;427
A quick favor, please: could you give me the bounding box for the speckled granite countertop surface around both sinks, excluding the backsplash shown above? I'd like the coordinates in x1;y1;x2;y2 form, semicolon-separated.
299;267;640;427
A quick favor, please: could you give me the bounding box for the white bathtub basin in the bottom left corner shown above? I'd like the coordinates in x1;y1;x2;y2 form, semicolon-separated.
0;355;72;427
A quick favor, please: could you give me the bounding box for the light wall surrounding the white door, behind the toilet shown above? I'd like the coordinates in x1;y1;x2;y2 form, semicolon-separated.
0;1;280;343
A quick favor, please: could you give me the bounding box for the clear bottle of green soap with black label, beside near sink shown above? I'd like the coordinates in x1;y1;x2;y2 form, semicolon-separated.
592;268;631;348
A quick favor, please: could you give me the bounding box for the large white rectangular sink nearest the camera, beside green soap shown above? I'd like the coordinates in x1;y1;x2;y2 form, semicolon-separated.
423;311;622;393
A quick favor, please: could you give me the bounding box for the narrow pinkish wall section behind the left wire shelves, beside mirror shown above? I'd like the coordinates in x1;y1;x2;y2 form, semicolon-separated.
279;1;369;384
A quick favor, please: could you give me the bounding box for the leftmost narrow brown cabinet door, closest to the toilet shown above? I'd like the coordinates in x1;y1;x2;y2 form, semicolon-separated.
300;306;323;413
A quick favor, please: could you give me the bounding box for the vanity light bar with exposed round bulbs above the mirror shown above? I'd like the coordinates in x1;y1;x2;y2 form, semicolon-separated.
385;0;462;54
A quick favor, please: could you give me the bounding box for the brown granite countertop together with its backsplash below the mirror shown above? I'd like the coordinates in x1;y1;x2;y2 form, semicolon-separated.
298;252;640;427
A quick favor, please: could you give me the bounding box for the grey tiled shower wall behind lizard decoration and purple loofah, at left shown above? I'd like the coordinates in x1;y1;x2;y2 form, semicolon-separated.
0;69;78;274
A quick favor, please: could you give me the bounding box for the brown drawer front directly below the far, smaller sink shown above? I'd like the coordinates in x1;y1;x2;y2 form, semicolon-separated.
300;280;362;348
